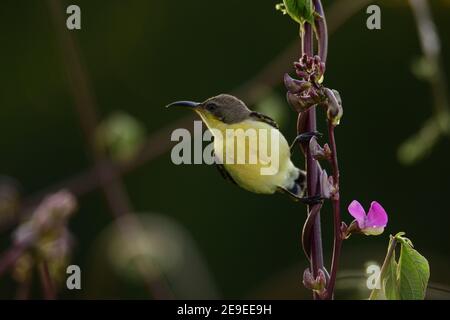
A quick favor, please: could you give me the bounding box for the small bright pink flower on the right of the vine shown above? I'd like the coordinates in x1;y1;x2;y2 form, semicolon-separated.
348;200;388;236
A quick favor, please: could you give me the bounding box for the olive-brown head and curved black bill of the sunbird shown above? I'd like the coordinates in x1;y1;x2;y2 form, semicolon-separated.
167;94;251;127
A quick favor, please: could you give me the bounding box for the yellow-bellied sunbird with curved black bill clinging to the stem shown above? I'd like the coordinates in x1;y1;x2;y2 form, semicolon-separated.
167;94;321;204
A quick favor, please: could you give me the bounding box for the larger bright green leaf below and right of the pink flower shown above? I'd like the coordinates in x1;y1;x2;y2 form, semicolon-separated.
398;239;430;300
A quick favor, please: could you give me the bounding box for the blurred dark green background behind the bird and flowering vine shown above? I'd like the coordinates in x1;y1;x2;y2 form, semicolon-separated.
0;0;450;299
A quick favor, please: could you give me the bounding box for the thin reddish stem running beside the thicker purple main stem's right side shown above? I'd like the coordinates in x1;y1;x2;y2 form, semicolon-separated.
327;121;343;299
